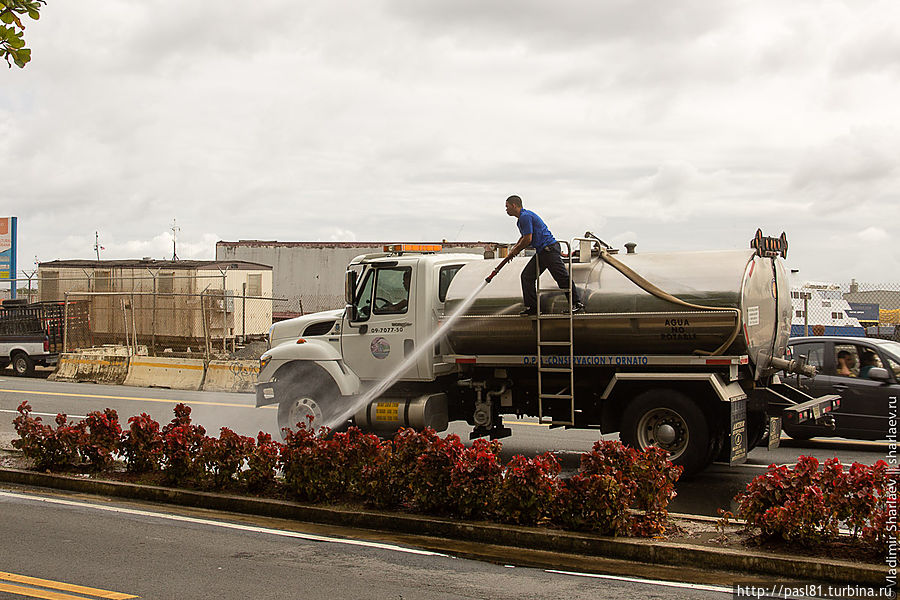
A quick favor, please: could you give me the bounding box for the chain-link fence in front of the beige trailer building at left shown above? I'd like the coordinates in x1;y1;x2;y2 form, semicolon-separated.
4;269;286;358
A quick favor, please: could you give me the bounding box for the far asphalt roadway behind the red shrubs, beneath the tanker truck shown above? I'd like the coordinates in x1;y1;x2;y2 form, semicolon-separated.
0;375;888;516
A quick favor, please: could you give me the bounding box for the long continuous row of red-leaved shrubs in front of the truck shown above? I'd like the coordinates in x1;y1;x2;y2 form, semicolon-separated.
13;402;681;536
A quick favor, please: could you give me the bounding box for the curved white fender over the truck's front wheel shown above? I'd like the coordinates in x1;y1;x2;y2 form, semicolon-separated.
257;339;360;406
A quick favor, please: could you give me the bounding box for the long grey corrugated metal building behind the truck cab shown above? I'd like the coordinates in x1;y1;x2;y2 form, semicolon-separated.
216;240;505;318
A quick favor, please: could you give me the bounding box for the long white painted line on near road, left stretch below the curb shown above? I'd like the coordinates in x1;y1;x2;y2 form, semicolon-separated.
0;491;447;557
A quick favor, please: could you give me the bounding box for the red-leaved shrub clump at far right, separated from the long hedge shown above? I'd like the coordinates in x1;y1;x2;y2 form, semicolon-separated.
735;456;896;546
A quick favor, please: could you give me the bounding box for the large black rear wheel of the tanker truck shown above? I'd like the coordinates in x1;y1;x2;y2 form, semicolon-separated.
620;389;712;477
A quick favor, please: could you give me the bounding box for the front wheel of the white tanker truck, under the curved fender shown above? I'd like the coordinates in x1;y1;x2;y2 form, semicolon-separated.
278;367;350;437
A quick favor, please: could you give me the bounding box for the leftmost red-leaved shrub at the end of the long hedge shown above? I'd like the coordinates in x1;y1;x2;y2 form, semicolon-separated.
12;402;84;470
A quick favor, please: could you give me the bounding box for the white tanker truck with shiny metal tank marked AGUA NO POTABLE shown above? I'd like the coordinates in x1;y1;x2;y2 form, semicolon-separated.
257;232;840;474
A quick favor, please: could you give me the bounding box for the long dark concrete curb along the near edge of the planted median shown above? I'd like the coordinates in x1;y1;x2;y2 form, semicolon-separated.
0;469;888;585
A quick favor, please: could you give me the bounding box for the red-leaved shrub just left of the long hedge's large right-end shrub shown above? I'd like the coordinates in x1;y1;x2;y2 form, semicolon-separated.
496;452;559;525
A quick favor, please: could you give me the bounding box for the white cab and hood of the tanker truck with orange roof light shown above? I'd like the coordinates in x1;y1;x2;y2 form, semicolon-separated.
257;245;484;428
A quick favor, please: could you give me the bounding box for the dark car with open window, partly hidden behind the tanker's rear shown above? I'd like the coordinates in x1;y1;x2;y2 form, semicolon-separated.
783;336;900;440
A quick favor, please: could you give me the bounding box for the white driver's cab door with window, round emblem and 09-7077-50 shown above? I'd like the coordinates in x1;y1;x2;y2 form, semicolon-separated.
341;265;419;381
